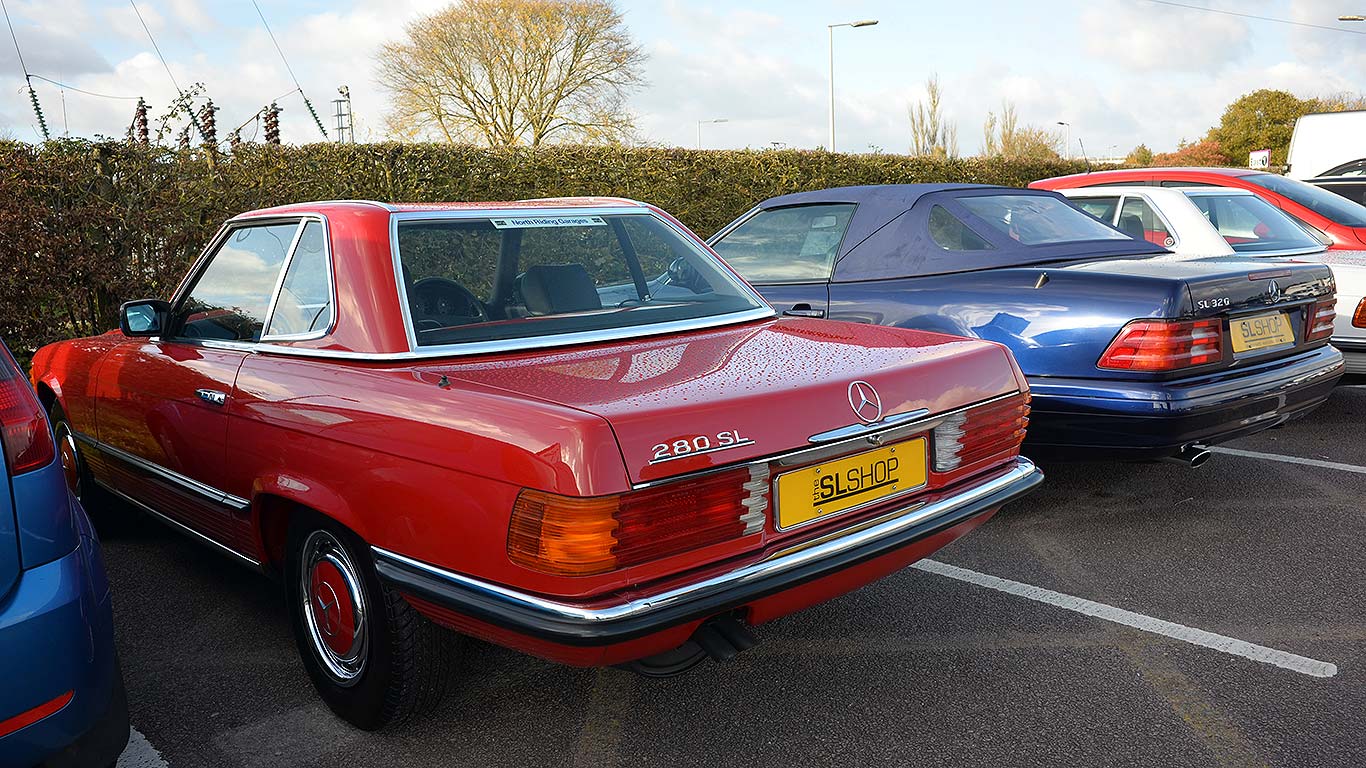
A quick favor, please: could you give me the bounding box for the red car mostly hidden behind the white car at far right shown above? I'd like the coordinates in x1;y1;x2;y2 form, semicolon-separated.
1030;168;1366;250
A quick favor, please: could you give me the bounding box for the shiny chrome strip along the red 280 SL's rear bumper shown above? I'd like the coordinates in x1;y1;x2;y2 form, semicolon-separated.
370;456;1041;626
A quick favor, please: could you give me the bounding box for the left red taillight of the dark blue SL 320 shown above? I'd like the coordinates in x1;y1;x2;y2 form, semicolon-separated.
1097;318;1224;370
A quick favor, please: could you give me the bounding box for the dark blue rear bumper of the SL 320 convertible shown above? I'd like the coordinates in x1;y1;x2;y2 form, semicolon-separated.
1025;346;1344;461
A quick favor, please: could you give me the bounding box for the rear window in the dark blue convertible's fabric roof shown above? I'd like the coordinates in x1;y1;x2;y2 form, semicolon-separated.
958;194;1128;246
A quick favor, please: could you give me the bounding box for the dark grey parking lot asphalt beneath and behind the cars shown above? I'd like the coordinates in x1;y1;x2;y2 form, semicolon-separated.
105;387;1366;768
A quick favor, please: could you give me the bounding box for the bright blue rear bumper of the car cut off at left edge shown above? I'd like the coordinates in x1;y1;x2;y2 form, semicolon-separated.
0;497;128;767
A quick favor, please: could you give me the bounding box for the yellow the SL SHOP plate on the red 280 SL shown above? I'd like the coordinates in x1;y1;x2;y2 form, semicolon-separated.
777;437;926;530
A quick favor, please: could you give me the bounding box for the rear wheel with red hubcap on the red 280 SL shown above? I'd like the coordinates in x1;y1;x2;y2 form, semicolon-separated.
285;514;458;731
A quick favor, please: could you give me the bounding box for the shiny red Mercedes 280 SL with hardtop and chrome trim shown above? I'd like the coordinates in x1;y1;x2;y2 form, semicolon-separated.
33;198;1042;728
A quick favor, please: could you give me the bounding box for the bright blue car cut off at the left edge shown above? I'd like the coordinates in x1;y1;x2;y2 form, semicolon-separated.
0;344;128;767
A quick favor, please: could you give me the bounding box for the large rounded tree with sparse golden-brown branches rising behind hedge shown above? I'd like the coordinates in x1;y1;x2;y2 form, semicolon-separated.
377;0;645;146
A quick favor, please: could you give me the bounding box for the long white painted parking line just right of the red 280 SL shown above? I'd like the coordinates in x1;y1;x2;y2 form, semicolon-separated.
912;560;1337;678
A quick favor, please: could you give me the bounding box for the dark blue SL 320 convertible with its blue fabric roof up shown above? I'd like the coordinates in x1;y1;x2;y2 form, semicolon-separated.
709;184;1343;465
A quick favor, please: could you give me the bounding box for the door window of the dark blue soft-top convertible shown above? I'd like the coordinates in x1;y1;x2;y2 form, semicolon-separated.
712;204;854;283
